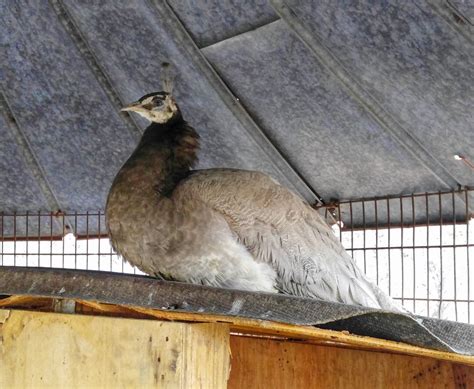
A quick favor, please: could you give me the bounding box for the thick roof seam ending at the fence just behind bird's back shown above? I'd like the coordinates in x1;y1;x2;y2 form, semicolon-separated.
150;0;322;203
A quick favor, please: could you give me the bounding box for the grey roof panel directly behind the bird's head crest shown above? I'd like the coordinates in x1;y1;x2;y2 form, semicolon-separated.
59;1;296;190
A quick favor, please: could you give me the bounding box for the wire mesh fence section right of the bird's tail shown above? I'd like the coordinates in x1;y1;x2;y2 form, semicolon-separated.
326;189;474;323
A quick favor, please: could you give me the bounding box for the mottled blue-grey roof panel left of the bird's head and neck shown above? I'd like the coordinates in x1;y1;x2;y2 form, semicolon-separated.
0;1;134;210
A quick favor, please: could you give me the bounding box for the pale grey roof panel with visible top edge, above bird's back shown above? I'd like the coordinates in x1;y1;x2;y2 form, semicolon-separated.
204;21;444;200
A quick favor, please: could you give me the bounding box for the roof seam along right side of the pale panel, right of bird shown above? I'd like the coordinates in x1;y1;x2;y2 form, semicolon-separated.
270;0;460;189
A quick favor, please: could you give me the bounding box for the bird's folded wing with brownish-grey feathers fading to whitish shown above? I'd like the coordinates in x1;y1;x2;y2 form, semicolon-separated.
176;169;394;309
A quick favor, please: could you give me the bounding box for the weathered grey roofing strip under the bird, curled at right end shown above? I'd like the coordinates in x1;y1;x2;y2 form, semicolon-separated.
0;267;474;355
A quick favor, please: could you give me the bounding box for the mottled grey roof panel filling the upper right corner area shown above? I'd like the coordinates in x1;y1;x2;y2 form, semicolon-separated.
284;0;474;190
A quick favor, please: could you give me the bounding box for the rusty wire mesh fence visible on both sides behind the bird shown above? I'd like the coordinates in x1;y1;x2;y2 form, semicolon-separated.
0;189;474;323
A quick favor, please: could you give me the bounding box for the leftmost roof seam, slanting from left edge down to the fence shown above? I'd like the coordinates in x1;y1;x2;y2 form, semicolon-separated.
0;92;68;226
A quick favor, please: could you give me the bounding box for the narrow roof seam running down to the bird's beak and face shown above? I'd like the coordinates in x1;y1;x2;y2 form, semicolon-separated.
51;0;142;141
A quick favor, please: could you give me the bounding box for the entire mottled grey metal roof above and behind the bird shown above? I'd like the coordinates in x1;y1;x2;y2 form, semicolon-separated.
0;0;474;223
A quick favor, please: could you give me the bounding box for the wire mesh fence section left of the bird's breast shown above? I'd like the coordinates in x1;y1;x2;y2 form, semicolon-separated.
0;212;143;274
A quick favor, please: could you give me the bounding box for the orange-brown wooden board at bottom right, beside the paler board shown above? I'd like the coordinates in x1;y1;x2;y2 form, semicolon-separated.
228;336;474;389
